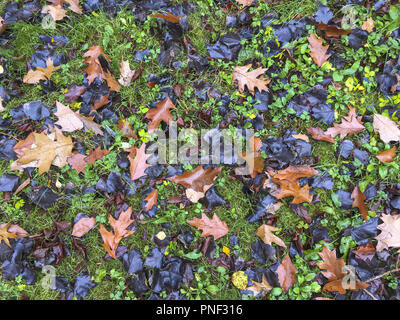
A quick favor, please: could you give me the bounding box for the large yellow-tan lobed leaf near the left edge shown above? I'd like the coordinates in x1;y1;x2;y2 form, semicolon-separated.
17;129;74;175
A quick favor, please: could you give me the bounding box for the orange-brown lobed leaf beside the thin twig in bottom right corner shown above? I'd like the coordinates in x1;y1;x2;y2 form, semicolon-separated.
317;246;369;294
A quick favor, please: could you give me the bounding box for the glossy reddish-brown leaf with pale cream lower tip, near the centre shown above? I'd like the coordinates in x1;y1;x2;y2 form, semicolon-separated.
167;165;222;203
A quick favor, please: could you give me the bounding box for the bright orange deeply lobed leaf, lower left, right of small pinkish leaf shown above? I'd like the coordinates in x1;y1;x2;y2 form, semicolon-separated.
100;207;135;259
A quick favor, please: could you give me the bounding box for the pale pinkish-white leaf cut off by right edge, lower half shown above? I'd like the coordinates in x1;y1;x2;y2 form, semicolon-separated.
375;213;400;251
